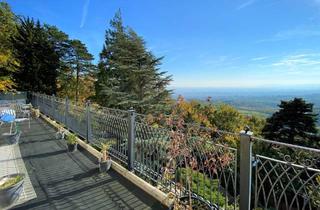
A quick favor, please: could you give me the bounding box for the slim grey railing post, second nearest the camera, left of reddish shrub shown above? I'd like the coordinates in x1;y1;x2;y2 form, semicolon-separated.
128;108;136;171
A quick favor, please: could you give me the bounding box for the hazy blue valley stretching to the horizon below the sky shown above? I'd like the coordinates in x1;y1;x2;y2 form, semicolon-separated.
173;88;320;125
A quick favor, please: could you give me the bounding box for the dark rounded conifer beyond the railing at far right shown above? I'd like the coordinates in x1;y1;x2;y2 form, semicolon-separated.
262;98;320;147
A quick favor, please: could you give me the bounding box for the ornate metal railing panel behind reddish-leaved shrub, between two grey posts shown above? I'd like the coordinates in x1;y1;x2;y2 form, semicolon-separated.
135;115;239;209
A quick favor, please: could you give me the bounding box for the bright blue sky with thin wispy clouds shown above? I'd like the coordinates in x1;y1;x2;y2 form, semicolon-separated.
7;0;320;88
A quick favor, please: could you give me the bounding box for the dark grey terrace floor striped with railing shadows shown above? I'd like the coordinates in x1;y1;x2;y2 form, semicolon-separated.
1;119;165;210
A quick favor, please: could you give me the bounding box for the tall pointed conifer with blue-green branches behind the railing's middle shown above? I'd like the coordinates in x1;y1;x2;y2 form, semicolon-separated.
95;12;171;113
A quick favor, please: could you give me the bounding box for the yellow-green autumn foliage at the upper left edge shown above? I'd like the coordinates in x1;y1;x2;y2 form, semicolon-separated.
0;2;19;92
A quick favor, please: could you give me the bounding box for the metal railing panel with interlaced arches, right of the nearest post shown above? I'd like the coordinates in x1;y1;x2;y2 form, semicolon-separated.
253;138;320;209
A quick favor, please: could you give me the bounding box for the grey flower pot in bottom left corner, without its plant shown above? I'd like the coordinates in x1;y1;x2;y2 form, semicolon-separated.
0;174;25;209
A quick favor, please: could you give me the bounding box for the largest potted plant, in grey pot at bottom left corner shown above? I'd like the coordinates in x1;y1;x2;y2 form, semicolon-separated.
0;173;25;209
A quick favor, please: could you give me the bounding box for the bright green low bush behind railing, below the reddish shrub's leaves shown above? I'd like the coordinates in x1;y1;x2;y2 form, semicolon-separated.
176;168;226;207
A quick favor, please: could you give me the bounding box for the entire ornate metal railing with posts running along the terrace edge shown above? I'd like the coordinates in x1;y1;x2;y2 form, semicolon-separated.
31;93;320;210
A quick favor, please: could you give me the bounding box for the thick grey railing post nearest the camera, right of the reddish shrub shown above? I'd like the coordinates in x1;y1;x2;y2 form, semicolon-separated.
240;130;252;210
